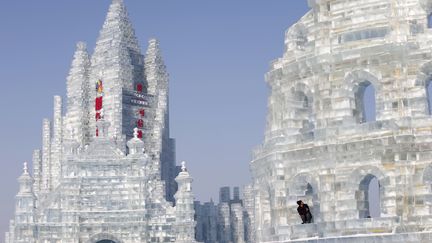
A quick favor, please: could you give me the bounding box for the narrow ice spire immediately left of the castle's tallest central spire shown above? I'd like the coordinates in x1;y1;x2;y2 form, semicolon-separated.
65;42;90;146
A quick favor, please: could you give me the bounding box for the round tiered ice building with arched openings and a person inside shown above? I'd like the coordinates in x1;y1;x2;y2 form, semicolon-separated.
250;0;432;242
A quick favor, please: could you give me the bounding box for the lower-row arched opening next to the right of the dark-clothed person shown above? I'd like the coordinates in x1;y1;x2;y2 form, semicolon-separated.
357;174;381;218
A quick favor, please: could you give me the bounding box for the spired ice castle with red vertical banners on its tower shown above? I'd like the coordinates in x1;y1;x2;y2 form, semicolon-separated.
6;0;195;243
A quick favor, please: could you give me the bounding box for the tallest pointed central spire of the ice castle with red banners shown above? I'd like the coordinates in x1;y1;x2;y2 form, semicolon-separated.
89;0;146;138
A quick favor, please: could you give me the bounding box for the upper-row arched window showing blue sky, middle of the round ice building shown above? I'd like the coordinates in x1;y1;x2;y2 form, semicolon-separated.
354;80;376;123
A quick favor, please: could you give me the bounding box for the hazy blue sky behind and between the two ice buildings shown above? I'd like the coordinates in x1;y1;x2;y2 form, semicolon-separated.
0;0;308;235
